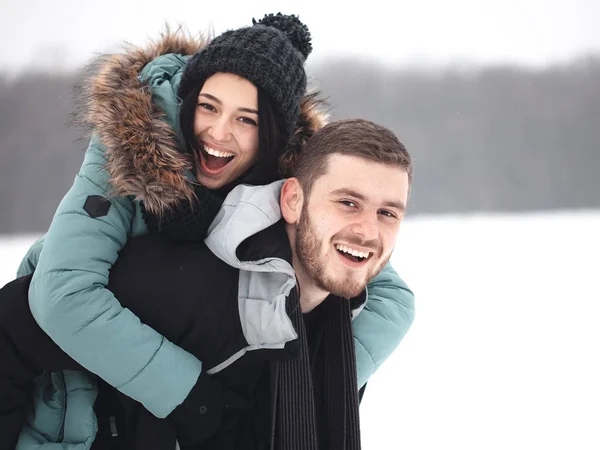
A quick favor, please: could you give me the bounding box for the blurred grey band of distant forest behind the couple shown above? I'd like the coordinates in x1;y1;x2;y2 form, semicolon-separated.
0;55;600;234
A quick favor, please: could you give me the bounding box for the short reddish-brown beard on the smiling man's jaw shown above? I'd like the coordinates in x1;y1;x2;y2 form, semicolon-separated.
296;204;389;299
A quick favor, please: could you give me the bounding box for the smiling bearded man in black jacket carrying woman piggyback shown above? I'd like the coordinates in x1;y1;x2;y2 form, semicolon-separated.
0;120;412;450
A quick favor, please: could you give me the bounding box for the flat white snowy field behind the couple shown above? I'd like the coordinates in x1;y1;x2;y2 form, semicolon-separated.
0;211;600;450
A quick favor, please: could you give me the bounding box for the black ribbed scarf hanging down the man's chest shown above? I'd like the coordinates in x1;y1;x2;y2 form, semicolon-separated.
271;290;361;450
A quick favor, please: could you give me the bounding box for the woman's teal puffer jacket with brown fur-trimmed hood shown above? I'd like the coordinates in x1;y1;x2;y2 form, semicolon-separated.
17;30;414;450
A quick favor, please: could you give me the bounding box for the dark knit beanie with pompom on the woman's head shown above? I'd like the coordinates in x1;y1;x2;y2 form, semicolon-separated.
178;13;312;136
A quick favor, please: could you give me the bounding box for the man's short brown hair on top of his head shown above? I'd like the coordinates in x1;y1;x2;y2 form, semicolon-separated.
294;119;412;196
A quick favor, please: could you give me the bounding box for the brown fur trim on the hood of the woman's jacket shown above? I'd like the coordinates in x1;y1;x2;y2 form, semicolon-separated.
75;29;327;214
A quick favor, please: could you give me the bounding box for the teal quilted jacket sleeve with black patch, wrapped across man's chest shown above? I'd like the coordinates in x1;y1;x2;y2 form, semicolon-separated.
26;134;201;418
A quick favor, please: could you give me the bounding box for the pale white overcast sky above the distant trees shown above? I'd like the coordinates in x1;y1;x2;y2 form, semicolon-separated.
0;0;600;72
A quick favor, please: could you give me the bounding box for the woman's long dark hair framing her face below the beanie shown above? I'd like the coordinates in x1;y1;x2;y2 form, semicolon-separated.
179;80;289;190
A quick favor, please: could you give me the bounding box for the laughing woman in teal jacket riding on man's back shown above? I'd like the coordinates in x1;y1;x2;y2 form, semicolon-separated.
9;15;413;448
